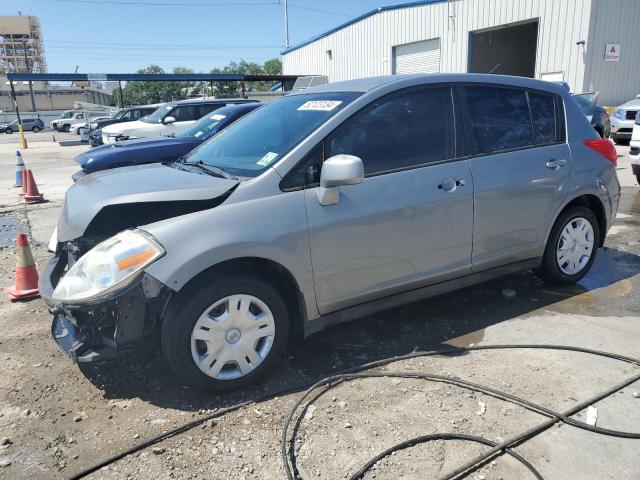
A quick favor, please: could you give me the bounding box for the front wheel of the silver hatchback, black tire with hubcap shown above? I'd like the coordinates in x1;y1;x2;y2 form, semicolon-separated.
160;275;289;392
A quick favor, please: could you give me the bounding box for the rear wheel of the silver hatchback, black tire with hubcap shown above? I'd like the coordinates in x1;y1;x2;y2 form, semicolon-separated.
540;206;600;285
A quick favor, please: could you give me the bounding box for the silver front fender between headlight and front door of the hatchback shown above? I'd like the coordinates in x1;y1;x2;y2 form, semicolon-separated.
143;191;318;318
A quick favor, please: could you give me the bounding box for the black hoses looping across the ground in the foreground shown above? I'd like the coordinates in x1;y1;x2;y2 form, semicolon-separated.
70;344;640;480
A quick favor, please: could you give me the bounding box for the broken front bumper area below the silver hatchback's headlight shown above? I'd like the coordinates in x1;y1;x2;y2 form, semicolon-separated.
39;249;171;363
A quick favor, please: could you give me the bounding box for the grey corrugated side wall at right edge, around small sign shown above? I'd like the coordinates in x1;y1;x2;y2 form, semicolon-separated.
584;0;640;105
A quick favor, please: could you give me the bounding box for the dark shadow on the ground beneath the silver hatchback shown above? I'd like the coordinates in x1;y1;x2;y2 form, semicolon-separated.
81;247;640;411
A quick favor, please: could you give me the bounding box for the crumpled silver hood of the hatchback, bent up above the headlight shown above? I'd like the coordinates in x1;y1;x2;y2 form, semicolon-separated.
58;164;238;242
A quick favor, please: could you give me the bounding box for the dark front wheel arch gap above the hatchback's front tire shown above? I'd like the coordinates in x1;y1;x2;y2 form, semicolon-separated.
161;257;307;339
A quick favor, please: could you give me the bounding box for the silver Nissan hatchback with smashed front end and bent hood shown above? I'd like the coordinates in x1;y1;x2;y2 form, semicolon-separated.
40;74;620;390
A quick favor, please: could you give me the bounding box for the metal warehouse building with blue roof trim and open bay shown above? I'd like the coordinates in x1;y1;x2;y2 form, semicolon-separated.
282;0;640;105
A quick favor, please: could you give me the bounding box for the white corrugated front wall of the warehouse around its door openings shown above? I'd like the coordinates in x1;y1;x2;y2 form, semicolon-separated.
283;0;596;91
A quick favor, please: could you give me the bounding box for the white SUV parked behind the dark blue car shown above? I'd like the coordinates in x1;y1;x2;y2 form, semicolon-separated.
102;98;256;145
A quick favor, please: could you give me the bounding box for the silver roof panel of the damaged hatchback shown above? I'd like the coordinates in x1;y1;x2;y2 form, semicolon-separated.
290;73;568;95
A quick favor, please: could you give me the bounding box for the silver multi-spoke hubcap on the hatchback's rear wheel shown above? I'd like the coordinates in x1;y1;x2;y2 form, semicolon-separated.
556;217;594;275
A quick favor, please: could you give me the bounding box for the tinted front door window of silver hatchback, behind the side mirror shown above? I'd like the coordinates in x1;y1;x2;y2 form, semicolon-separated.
326;87;455;175
